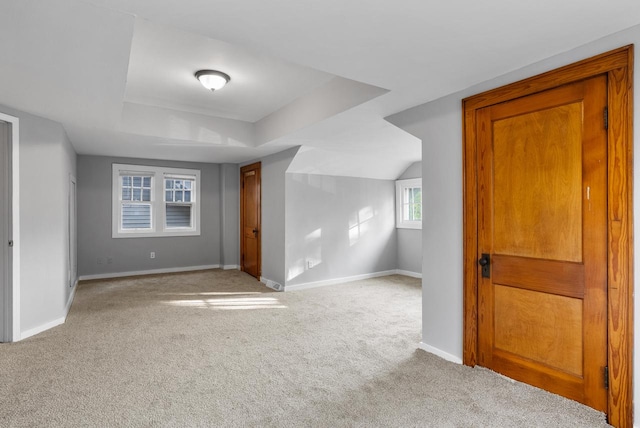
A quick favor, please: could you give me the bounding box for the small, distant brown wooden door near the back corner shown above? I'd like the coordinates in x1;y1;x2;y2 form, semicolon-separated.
240;162;261;280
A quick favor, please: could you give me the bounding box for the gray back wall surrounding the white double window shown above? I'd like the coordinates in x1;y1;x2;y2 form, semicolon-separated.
78;156;225;276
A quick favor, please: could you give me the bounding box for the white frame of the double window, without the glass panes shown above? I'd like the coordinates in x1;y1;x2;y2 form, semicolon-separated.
111;163;201;238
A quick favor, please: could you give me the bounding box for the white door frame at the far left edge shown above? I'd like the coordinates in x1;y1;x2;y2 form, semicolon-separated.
0;112;21;342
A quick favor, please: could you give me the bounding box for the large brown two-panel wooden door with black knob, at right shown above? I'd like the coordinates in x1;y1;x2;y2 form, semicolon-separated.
476;76;607;411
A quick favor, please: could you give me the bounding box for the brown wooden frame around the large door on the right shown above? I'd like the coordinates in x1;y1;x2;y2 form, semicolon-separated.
462;45;633;427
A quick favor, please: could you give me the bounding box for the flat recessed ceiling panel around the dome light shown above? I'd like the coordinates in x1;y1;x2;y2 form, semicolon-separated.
125;19;334;122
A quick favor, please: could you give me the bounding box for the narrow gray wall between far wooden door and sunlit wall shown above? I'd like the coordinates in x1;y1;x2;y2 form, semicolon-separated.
254;147;299;285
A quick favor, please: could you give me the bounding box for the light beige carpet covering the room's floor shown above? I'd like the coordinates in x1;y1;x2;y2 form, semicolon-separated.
0;270;607;427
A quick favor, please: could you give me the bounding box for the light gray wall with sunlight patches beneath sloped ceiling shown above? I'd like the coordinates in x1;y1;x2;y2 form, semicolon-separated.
285;174;397;286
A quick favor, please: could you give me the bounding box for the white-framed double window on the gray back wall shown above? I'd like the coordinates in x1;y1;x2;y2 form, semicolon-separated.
112;164;200;238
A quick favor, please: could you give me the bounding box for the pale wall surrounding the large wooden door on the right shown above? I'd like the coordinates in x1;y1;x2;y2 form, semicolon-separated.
388;26;640;422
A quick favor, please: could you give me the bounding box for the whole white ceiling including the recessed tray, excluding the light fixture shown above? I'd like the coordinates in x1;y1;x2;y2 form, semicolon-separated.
0;0;640;179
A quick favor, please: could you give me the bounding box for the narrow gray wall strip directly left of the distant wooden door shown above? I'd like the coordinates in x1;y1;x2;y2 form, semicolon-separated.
220;163;240;269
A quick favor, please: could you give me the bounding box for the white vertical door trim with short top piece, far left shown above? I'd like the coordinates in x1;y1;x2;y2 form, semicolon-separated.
0;113;22;342
